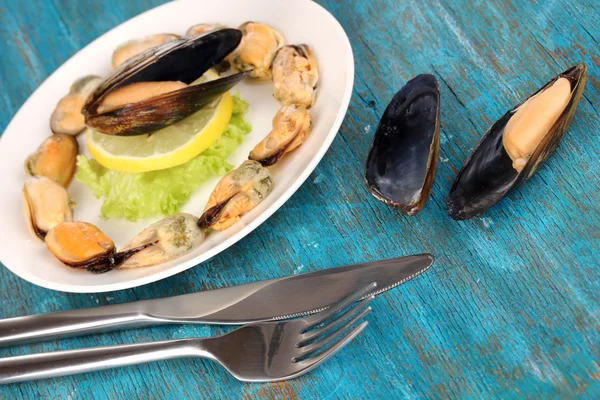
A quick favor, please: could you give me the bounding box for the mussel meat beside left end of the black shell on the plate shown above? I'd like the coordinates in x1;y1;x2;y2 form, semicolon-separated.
50;75;102;135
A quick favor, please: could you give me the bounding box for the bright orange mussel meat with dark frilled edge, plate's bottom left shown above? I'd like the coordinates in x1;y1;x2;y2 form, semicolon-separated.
44;222;155;274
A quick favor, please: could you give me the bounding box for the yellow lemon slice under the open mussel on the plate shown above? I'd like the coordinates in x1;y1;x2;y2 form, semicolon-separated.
86;70;233;172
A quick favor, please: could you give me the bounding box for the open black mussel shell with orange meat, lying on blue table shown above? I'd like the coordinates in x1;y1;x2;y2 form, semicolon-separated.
447;64;587;220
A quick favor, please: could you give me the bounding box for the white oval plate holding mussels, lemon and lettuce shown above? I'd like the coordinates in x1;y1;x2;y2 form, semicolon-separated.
0;0;354;293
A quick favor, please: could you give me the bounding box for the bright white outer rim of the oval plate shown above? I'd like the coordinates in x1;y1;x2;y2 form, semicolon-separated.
0;0;355;293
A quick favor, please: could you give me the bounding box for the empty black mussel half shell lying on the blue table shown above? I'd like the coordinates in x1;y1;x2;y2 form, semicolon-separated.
365;74;440;215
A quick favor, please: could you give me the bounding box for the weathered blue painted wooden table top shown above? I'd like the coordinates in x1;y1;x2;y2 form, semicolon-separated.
0;0;600;399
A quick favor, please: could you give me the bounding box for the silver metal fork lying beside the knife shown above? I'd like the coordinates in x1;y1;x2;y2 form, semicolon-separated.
0;283;377;384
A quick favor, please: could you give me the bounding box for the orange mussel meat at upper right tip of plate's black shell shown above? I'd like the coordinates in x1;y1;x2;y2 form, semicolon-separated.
233;21;285;79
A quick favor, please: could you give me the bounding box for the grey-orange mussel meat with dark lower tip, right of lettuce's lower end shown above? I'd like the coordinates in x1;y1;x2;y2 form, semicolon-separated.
198;160;273;231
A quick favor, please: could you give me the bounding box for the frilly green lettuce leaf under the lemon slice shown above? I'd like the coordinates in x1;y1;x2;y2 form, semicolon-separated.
75;95;252;221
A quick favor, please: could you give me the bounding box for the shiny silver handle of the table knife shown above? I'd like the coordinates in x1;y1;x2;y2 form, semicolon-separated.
0;300;171;347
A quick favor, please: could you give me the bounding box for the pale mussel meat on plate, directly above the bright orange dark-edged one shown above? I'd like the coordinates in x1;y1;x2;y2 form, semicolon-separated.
23;176;73;240
